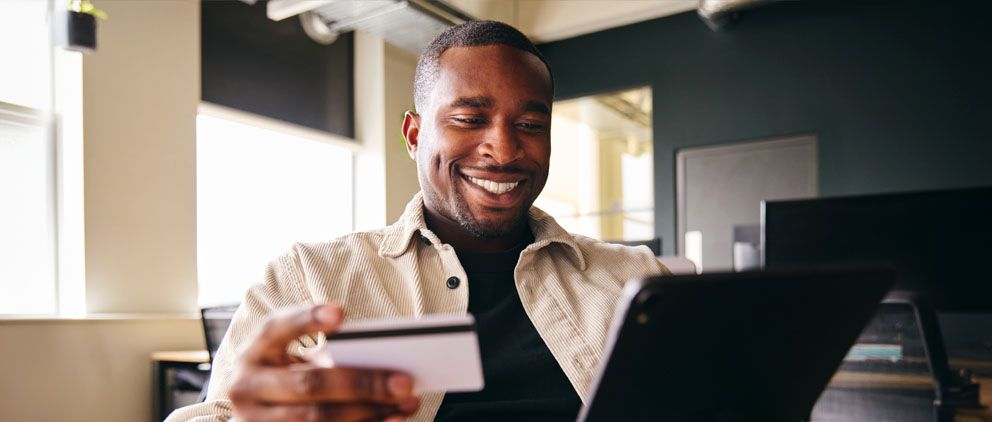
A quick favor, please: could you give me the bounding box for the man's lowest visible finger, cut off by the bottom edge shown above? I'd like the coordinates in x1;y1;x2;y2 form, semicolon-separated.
235;398;419;422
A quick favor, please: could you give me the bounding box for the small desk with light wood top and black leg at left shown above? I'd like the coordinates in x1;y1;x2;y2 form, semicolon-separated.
151;350;210;422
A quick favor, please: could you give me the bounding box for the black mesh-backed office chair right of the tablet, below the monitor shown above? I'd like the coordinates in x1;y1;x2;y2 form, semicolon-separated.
812;291;981;422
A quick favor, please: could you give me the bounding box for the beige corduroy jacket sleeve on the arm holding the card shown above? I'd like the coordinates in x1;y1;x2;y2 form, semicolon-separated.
165;248;314;422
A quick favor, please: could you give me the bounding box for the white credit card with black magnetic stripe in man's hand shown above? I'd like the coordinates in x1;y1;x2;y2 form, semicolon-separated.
305;314;485;393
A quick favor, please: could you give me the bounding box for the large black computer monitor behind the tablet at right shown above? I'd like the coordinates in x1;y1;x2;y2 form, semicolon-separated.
762;187;992;312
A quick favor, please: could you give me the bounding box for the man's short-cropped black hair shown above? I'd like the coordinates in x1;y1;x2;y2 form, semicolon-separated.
413;20;554;110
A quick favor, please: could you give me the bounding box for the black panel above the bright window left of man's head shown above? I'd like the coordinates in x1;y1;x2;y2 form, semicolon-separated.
200;0;355;138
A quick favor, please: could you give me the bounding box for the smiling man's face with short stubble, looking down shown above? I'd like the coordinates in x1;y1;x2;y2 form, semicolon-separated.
404;45;552;238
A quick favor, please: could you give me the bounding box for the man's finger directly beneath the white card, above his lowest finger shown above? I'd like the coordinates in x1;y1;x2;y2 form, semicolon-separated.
229;366;413;405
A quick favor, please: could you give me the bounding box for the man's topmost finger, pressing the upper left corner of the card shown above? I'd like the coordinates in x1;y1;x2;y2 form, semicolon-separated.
242;305;344;364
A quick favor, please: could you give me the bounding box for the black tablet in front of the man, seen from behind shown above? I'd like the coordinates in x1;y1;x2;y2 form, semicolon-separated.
578;267;894;422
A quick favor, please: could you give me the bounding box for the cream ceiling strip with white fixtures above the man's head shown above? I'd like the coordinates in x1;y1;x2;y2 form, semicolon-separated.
264;0;699;53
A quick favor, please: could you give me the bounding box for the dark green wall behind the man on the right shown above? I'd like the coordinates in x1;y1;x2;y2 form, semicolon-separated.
539;1;992;254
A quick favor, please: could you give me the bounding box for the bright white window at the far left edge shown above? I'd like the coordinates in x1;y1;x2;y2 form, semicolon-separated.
0;1;57;314
